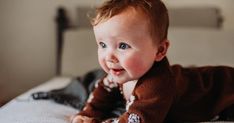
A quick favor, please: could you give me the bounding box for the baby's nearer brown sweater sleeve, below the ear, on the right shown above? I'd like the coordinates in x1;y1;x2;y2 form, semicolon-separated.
118;74;175;123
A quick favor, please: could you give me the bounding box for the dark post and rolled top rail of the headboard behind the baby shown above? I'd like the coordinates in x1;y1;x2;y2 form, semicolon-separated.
56;7;225;75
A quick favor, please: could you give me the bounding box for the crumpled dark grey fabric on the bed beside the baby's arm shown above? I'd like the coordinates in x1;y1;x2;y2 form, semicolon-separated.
32;69;125;117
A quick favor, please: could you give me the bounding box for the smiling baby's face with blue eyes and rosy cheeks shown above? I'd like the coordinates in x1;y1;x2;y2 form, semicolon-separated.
94;9;158;84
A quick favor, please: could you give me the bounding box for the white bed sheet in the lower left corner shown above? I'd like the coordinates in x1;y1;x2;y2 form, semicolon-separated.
0;77;78;123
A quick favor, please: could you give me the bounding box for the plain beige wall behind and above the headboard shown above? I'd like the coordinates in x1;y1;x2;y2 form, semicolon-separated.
0;0;234;99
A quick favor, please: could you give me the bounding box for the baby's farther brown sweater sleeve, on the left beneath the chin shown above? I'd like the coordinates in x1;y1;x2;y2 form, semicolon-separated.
78;78;120;121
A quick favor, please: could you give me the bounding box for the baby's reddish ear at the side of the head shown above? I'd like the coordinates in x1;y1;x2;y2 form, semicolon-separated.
155;39;170;61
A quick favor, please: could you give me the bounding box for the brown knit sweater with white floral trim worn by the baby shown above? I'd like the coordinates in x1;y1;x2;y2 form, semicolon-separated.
79;58;234;123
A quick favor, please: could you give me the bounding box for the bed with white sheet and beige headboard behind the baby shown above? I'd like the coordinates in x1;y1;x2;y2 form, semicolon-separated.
0;7;234;123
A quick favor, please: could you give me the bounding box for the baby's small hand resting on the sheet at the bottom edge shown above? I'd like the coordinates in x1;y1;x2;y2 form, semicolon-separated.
70;115;98;123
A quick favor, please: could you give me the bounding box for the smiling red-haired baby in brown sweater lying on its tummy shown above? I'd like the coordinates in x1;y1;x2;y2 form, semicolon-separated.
71;0;234;123
